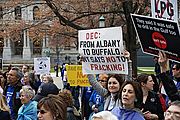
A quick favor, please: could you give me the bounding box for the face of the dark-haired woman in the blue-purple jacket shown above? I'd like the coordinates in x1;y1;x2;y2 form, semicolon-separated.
121;84;136;107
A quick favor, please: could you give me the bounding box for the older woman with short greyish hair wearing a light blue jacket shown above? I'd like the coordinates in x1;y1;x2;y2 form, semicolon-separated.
17;85;37;120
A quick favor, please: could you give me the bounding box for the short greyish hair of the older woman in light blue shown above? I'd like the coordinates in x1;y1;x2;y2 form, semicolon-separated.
20;85;35;99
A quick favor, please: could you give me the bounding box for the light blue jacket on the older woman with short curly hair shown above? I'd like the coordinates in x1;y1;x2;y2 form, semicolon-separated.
17;101;37;120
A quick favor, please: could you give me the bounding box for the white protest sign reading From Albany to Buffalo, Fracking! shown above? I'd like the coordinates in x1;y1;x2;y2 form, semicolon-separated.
78;27;128;74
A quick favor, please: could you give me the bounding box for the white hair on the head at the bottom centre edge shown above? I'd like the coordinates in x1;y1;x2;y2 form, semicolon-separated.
92;111;118;120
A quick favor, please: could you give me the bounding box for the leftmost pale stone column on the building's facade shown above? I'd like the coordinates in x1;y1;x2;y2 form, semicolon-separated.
3;36;12;60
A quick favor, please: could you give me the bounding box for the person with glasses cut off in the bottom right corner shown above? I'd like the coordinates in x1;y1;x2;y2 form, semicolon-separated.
164;100;180;120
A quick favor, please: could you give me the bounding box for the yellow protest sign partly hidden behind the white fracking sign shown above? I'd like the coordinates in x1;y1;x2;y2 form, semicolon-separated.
66;65;90;87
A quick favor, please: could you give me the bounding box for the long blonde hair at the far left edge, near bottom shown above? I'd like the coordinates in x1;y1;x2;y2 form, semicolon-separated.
0;93;10;112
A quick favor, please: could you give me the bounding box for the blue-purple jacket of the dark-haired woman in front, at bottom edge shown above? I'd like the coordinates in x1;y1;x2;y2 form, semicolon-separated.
111;107;145;120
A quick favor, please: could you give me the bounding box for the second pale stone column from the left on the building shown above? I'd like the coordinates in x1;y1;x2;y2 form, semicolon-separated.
23;30;31;60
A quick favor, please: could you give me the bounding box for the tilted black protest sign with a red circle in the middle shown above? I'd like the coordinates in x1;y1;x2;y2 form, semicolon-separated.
131;14;180;62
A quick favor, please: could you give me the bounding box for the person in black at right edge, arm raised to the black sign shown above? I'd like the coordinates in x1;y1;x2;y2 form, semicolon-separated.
158;52;180;102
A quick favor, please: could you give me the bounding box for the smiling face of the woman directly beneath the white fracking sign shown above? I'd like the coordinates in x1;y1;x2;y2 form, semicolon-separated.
108;77;120;93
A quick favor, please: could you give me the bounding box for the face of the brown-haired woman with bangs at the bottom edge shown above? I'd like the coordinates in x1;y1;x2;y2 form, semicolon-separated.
38;106;53;120
